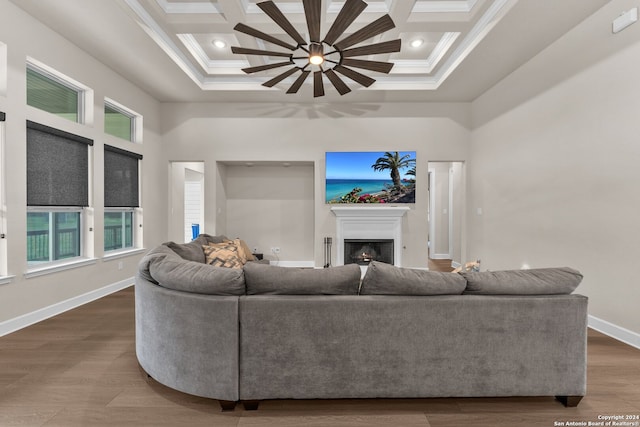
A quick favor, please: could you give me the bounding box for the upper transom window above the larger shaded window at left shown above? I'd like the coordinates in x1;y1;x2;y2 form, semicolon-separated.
27;63;84;123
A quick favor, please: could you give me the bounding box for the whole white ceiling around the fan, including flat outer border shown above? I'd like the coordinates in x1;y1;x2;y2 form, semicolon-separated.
14;0;607;102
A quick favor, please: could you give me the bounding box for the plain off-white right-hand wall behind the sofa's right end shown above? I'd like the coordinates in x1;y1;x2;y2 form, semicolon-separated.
467;0;640;338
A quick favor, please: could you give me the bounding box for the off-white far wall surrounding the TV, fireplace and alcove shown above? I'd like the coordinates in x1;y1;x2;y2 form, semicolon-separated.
161;103;470;267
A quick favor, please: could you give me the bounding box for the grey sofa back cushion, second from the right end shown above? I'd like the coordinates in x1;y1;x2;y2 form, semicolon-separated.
360;261;467;295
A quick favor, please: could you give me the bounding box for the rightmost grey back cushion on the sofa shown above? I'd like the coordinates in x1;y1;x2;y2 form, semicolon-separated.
460;267;582;295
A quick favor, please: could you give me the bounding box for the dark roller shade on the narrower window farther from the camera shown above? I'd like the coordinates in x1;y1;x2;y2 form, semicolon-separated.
104;145;142;208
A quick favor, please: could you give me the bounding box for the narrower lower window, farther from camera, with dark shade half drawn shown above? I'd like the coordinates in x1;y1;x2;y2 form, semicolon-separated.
104;145;142;252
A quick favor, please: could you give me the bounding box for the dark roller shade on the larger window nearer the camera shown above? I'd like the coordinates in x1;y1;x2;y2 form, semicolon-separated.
27;121;93;206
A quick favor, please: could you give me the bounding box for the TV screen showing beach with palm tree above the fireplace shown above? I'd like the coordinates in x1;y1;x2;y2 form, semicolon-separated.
325;151;416;203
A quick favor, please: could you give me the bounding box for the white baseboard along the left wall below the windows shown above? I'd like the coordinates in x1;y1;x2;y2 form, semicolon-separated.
0;277;134;337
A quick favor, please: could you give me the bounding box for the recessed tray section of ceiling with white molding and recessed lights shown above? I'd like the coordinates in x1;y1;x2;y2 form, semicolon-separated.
125;0;517;91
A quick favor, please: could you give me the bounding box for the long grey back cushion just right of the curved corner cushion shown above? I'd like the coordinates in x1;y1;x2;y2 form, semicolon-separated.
244;262;361;295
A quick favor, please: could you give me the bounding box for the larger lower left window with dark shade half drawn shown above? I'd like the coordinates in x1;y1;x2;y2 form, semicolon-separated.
27;121;93;264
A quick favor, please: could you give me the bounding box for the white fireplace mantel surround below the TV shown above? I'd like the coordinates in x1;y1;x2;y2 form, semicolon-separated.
331;206;409;266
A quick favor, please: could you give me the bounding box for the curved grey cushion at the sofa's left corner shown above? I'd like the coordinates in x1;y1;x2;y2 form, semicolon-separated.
138;245;244;295
